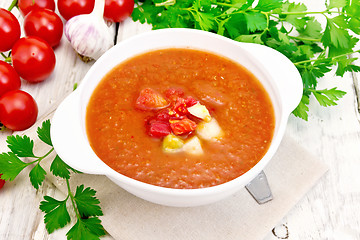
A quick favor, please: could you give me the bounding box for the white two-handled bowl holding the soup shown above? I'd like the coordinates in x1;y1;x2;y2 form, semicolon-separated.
51;29;302;207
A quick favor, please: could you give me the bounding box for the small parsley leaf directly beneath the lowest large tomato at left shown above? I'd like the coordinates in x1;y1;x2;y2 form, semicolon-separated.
6;135;35;157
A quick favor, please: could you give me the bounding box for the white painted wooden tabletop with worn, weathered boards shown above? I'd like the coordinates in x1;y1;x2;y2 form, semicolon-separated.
0;0;360;240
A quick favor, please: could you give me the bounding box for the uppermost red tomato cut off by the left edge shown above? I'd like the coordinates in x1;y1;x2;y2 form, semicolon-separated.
0;8;21;52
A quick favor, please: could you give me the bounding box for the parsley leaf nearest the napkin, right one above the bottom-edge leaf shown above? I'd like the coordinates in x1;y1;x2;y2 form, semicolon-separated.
74;185;103;217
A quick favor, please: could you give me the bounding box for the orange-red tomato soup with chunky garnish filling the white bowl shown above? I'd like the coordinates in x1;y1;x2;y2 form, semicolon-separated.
86;48;275;189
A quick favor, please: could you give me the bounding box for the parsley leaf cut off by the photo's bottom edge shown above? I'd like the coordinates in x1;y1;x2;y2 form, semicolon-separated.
66;217;105;240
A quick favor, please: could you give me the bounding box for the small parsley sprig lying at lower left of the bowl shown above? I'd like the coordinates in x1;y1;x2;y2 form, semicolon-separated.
0;120;105;240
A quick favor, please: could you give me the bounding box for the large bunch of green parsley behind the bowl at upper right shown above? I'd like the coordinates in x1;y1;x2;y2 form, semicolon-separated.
132;0;360;120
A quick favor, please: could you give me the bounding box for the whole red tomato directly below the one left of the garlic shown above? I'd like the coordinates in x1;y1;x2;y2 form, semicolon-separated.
11;36;56;82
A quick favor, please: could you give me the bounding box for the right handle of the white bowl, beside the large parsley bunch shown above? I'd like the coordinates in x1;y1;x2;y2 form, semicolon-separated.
240;43;303;115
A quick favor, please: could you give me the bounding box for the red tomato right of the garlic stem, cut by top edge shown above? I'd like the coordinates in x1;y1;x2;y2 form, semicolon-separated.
104;0;134;22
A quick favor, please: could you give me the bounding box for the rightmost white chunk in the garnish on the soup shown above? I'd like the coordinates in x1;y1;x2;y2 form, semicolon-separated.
196;118;224;141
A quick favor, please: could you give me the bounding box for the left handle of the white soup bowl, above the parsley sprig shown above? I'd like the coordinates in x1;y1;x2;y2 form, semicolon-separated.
50;91;109;174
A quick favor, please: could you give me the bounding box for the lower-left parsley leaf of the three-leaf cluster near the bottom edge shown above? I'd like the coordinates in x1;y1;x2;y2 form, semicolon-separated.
40;196;71;233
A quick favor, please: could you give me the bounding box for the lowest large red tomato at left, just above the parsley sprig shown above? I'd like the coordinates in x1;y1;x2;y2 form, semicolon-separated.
0;90;38;131
